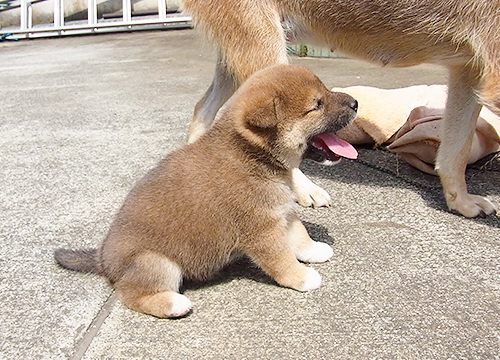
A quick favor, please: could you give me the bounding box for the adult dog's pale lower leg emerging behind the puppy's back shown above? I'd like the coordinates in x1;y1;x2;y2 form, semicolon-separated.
188;56;238;143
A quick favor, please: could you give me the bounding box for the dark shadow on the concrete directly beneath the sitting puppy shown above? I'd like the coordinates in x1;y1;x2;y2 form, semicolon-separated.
180;221;333;293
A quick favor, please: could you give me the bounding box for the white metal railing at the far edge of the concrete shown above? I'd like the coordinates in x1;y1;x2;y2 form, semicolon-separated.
0;0;192;40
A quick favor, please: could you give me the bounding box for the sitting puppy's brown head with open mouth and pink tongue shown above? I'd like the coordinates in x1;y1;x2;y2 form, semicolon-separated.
228;65;357;168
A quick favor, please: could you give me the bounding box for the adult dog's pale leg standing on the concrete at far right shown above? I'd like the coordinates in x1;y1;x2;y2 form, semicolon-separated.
436;66;496;217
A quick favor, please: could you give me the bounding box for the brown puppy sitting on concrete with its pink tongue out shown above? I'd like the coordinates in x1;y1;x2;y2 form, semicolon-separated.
55;65;357;317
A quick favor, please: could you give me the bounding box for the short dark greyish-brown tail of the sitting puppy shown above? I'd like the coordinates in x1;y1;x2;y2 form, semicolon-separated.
54;249;103;275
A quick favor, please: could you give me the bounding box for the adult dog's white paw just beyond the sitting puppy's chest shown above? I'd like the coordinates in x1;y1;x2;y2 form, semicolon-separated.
292;169;332;207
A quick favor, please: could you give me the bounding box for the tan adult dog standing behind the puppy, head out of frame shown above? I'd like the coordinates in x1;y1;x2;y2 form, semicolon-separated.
183;0;500;217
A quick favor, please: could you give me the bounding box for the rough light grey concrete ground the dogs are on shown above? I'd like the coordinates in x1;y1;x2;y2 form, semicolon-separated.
0;30;500;359
